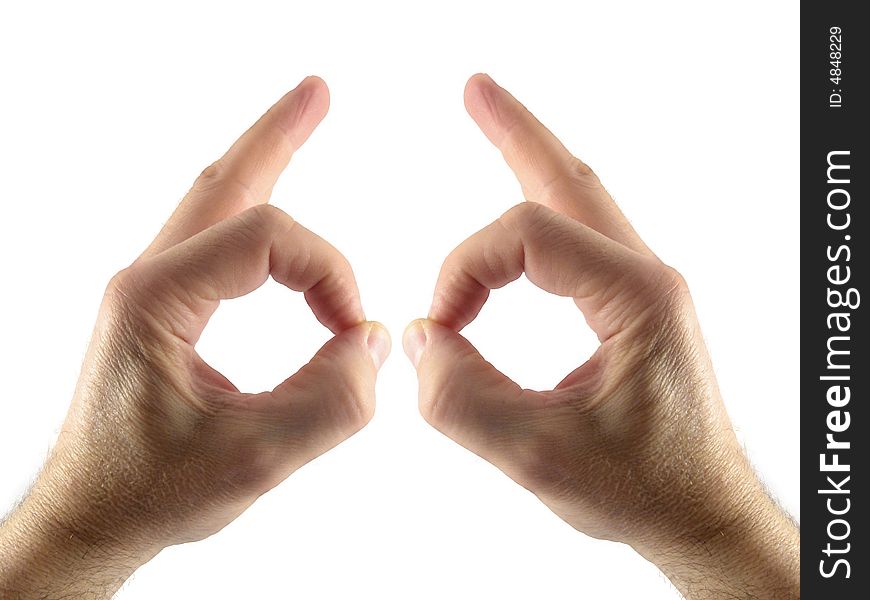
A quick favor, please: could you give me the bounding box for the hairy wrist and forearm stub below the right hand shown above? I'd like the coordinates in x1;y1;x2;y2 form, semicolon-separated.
637;493;800;600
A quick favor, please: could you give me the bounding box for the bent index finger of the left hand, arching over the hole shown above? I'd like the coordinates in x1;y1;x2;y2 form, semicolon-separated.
131;205;365;344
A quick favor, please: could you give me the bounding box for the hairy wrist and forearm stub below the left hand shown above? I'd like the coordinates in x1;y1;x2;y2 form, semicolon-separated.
0;494;154;599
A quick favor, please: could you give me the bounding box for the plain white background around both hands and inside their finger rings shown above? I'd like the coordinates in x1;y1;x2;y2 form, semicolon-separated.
0;1;800;599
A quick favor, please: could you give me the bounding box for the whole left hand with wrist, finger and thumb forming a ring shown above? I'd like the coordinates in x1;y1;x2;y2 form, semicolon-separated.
0;78;390;598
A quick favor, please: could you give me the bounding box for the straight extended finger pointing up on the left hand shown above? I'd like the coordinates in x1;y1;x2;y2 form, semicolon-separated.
142;77;329;257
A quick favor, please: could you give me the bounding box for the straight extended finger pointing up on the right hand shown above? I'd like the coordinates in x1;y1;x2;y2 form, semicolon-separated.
465;74;651;253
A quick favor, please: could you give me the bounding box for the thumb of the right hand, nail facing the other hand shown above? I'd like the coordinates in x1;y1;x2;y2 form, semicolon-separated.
403;319;539;475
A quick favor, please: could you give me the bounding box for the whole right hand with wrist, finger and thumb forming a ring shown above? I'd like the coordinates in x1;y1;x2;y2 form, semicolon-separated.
404;75;800;598
